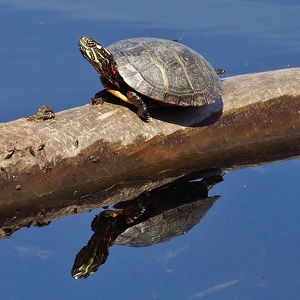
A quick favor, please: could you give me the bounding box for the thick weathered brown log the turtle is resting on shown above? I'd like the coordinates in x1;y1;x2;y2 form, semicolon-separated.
0;68;300;236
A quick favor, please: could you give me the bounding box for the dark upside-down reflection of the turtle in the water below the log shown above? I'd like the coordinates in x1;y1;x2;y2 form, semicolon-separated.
71;171;223;279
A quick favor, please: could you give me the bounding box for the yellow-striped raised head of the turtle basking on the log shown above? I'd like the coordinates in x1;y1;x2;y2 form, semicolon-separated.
78;36;113;74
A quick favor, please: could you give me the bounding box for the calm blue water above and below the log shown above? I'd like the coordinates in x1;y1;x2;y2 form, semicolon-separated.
0;0;300;300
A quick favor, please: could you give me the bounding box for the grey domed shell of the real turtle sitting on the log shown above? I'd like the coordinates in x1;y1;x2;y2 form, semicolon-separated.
107;38;222;106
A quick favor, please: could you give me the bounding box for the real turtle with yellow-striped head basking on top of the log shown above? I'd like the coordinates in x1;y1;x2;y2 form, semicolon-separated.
78;36;224;120
